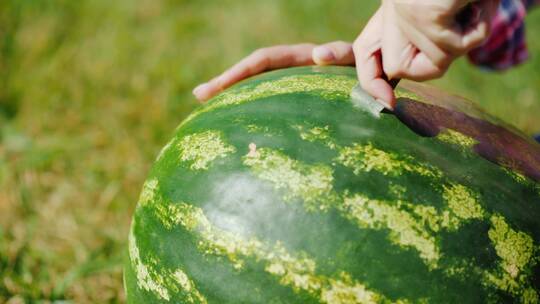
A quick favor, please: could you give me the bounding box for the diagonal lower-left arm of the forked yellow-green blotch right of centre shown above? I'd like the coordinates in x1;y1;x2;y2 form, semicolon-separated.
341;194;441;268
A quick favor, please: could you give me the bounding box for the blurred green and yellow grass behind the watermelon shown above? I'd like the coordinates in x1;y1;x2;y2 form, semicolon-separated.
0;0;540;303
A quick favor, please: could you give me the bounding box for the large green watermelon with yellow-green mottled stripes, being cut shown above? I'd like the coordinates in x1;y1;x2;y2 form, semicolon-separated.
125;67;540;304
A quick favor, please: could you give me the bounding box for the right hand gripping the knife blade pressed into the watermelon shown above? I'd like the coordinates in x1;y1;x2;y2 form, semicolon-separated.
353;0;499;109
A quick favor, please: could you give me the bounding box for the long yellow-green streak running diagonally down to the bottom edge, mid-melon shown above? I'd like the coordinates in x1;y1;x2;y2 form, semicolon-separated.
162;203;406;304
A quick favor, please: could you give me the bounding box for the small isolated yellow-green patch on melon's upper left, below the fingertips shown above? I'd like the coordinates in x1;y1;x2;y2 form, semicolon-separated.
177;130;236;170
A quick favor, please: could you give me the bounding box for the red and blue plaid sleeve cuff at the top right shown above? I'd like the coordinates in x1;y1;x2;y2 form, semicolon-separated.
469;0;540;70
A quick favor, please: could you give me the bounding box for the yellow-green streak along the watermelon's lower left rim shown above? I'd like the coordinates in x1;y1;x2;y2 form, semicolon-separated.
128;225;207;304
